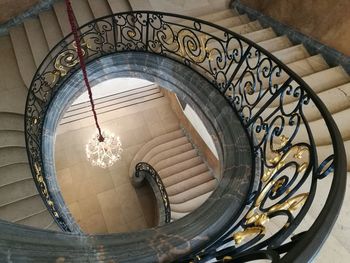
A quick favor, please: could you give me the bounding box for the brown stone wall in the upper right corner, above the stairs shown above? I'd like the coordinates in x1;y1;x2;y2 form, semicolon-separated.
241;0;350;56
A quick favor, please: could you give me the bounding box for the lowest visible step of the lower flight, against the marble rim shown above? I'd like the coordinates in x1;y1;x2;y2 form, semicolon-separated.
170;192;212;214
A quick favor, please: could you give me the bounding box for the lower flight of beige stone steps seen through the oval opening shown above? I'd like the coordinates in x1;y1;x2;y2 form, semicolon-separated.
129;130;217;220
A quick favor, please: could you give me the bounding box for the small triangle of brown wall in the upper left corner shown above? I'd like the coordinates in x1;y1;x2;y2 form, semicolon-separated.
0;0;40;24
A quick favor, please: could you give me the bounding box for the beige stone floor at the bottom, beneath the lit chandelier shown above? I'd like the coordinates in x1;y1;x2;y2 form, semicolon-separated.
55;92;178;233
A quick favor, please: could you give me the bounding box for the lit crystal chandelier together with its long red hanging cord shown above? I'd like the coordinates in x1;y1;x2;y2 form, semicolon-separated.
65;0;123;168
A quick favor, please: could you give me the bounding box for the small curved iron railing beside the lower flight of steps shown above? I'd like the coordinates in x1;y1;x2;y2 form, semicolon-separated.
135;162;171;223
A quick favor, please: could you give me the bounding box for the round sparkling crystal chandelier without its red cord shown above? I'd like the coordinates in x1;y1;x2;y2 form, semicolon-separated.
86;131;123;168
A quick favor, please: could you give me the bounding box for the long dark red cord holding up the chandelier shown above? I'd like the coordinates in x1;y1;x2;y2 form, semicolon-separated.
65;0;104;142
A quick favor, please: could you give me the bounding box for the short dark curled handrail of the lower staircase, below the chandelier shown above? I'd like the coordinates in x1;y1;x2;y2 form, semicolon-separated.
134;162;171;225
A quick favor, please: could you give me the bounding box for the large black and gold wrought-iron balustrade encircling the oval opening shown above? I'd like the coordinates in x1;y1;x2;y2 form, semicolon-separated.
25;11;346;262
